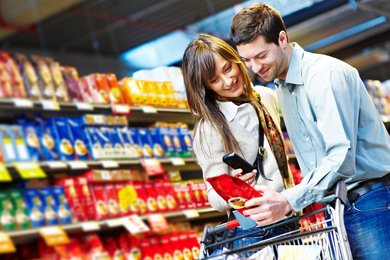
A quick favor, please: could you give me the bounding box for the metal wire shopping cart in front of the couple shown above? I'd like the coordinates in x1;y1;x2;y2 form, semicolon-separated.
200;182;352;260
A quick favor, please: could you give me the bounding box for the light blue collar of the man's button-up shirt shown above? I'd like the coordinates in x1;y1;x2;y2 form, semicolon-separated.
274;42;305;87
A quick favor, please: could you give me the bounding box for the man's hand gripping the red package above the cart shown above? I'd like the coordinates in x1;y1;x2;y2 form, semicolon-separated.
243;185;292;226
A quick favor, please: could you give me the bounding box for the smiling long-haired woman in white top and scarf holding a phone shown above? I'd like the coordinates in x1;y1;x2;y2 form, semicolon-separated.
182;34;293;257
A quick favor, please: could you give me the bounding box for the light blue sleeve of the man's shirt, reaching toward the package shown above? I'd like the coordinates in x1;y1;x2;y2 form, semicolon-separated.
282;65;359;211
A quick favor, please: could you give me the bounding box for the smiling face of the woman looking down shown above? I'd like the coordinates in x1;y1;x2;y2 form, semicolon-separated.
208;53;244;100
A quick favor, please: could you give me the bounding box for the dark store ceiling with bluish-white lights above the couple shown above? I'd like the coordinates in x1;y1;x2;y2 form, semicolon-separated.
0;0;390;81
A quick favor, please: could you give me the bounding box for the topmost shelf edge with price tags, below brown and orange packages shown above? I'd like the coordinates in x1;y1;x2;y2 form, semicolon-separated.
0;99;193;124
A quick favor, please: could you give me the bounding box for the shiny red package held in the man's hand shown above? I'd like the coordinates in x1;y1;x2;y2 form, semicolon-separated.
206;174;262;213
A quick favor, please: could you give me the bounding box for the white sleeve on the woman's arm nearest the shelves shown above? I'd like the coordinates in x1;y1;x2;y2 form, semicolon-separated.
193;123;230;211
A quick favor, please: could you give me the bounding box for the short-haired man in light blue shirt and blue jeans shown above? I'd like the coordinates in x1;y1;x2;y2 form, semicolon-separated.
231;4;390;259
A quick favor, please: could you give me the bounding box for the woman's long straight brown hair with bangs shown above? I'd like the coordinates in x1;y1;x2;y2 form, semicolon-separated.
182;34;262;153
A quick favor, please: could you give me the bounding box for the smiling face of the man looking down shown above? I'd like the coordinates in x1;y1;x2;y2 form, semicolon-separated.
237;36;287;82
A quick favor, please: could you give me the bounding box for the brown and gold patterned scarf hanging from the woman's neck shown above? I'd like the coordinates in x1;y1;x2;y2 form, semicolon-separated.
256;96;294;188
